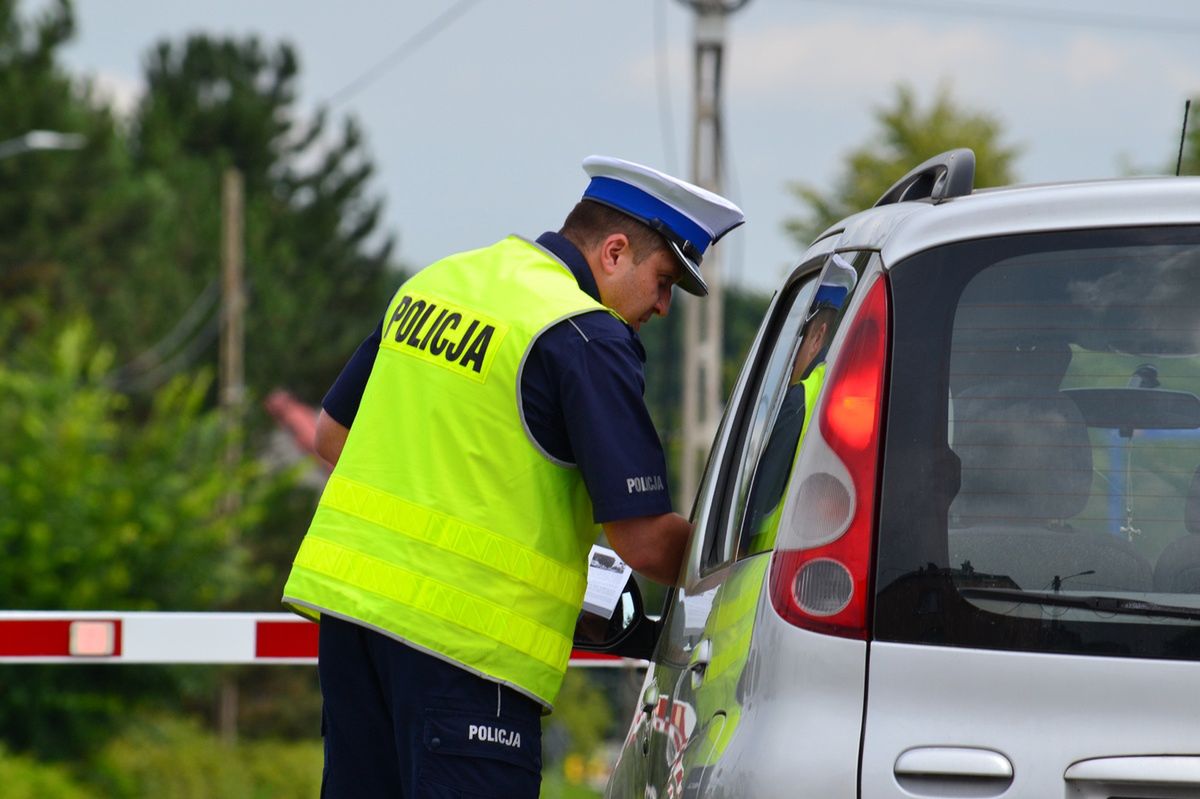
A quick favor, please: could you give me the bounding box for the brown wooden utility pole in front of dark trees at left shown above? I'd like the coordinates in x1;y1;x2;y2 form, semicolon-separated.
217;168;246;743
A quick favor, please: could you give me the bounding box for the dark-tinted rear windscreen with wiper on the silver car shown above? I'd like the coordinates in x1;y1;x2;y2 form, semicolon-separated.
875;228;1200;659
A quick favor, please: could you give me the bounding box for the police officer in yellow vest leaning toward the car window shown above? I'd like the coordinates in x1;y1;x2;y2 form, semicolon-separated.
283;156;743;798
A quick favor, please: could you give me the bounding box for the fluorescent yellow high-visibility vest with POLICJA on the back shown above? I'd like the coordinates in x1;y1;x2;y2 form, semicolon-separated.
283;236;606;707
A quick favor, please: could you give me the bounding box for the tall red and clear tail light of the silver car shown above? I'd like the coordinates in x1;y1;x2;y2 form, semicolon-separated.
770;276;888;639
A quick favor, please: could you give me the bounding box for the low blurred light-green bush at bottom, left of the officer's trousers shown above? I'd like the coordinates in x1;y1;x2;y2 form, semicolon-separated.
95;717;323;799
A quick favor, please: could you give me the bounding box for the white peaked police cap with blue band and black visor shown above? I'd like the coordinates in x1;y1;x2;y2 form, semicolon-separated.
583;156;745;296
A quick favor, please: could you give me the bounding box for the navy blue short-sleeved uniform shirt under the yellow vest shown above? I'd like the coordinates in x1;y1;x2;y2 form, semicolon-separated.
322;226;671;522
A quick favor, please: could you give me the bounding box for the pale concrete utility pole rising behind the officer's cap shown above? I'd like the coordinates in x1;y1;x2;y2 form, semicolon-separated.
679;0;749;507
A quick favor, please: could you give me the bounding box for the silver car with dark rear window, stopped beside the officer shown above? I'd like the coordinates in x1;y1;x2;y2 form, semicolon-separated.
580;150;1200;799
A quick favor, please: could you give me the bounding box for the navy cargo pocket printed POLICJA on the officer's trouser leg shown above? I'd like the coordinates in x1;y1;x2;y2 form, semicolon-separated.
416;709;541;799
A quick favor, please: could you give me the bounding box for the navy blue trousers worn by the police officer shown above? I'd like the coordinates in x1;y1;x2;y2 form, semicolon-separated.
317;615;541;799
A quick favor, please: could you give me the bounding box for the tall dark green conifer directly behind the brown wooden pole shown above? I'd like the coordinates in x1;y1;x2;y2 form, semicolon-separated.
132;35;397;401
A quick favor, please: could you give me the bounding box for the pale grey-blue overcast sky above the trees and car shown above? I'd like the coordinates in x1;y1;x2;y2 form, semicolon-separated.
51;0;1200;289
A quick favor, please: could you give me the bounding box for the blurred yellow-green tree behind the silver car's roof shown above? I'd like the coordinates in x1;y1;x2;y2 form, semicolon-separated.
785;85;1020;246
